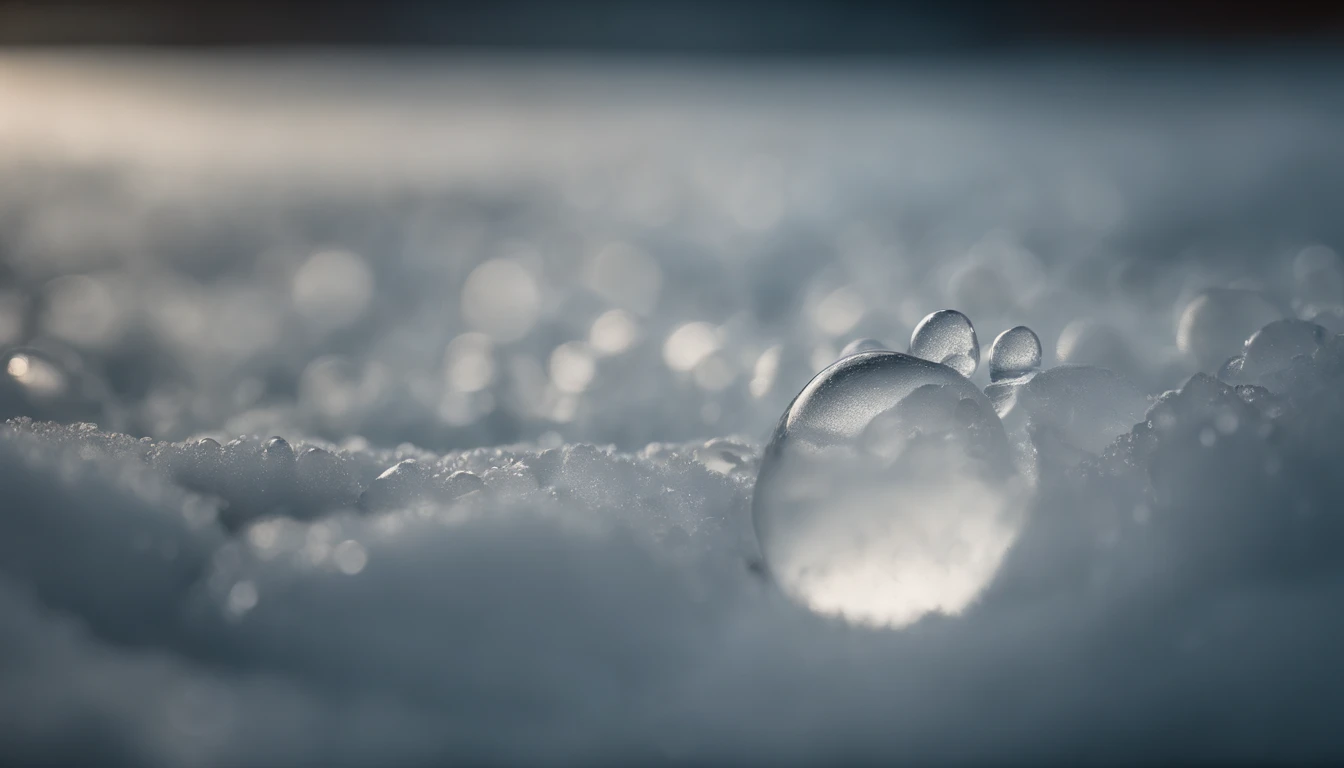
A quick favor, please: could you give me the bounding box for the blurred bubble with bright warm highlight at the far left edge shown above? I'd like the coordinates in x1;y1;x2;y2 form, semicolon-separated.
0;346;124;430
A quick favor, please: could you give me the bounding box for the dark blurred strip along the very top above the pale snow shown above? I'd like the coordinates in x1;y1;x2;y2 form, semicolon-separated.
0;0;1344;54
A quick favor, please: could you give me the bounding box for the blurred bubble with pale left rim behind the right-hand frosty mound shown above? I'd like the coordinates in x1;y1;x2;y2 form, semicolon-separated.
1176;288;1284;371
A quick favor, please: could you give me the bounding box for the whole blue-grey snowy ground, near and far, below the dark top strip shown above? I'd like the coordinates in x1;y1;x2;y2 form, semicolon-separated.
0;52;1344;767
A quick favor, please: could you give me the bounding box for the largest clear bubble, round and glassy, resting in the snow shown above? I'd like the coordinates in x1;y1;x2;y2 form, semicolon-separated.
751;351;1019;625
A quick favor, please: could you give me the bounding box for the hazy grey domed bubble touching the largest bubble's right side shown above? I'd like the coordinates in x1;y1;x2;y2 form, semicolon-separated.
1017;366;1148;455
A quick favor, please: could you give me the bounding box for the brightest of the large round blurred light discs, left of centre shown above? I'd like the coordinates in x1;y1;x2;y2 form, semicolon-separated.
462;258;542;342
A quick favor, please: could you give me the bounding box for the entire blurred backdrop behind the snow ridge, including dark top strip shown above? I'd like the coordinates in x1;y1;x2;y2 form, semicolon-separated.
0;0;1344;451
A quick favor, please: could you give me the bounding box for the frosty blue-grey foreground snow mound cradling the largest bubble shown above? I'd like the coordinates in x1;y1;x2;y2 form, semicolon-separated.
0;337;1344;767
